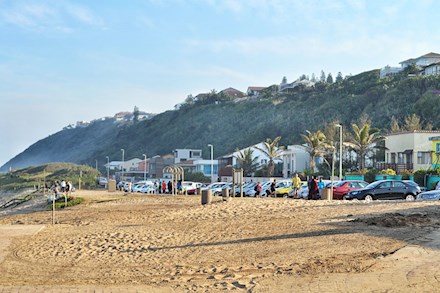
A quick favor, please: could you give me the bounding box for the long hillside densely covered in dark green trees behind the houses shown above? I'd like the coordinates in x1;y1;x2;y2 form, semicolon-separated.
0;70;440;172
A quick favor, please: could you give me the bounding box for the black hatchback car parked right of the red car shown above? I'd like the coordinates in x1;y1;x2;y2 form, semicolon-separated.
345;180;421;201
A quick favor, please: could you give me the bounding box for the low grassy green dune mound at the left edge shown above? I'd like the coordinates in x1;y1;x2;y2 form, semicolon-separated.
0;163;98;190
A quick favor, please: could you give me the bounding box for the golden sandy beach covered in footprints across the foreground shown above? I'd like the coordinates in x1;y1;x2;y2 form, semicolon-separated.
0;191;440;292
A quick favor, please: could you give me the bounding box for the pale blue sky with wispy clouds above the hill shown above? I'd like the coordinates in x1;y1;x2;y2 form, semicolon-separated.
0;0;440;165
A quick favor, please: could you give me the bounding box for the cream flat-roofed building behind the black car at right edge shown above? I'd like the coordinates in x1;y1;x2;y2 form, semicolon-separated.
376;130;440;172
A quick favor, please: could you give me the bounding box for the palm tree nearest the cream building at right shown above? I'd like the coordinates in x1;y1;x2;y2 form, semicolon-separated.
344;123;385;170
